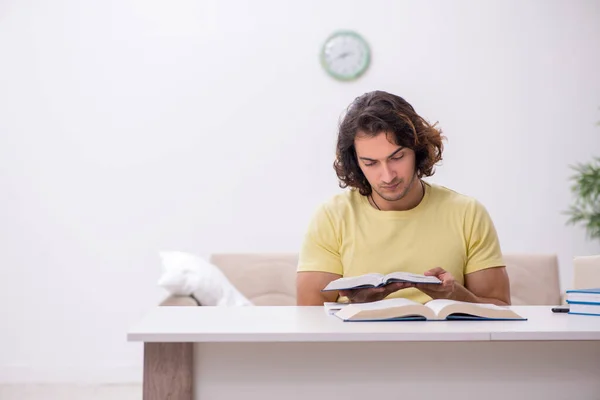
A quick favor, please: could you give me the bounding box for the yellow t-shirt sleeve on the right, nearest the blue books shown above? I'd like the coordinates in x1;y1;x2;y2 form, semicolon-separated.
464;200;504;275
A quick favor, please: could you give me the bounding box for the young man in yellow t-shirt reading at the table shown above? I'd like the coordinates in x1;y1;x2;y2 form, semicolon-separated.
297;91;510;305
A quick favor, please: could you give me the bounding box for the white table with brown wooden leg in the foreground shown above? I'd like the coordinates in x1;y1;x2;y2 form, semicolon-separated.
128;306;600;400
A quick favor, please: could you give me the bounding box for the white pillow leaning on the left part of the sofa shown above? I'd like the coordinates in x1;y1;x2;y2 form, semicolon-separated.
158;251;252;306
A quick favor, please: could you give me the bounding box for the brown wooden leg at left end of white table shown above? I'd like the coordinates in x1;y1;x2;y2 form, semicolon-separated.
143;343;194;400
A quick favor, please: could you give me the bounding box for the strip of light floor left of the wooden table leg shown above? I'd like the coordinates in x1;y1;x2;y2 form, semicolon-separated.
0;384;142;400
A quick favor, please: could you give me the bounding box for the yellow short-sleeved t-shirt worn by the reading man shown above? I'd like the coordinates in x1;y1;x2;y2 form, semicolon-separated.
297;183;504;303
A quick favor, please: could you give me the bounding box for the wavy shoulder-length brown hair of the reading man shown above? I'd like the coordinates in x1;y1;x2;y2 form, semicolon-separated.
333;91;445;196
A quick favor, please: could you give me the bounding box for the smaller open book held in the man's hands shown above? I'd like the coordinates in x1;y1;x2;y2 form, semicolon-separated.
321;272;442;292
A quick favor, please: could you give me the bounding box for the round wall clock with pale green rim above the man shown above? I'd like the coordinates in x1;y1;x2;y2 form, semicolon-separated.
321;31;371;81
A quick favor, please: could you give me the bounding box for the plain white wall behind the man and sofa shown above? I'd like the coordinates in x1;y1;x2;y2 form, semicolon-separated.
0;0;600;381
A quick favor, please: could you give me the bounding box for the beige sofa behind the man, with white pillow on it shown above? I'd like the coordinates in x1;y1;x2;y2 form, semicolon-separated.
161;253;563;306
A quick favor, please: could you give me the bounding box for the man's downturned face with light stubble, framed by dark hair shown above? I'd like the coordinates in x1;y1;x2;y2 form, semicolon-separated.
354;133;416;201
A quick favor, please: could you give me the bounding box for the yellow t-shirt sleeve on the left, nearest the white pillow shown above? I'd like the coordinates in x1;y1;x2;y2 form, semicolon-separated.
297;205;343;275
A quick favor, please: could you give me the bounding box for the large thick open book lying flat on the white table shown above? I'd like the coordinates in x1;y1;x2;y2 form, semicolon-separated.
334;298;526;321
